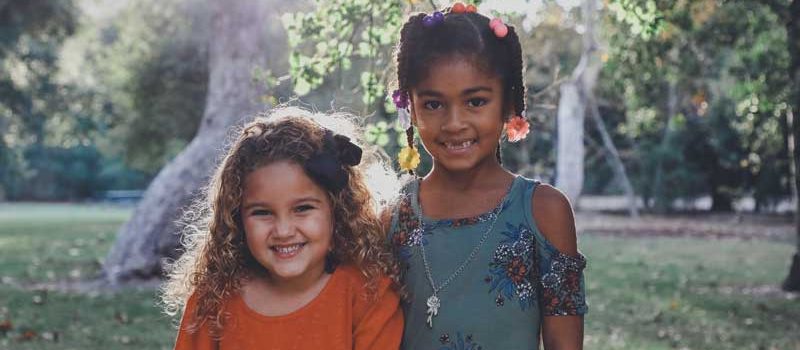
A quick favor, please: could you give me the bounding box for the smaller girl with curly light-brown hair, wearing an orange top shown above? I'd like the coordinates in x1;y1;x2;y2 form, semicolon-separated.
164;109;403;350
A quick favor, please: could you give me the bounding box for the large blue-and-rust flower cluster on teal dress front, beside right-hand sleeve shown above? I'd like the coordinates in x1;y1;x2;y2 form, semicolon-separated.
484;223;536;310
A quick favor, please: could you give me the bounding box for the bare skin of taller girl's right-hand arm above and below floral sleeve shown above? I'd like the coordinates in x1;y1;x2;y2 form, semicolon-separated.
531;184;583;350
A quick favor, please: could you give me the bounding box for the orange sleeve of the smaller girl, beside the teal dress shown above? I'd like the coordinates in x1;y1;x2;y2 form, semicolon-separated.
353;278;403;350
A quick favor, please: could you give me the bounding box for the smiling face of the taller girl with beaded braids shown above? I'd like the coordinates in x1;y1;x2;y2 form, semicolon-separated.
411;57;504;172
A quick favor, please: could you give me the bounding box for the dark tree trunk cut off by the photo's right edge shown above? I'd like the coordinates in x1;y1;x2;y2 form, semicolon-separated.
783;0;800;292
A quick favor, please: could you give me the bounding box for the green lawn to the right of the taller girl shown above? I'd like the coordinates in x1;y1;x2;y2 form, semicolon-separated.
580;235;800;350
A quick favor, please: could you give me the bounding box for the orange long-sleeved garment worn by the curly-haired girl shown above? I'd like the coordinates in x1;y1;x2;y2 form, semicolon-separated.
175;266;403;350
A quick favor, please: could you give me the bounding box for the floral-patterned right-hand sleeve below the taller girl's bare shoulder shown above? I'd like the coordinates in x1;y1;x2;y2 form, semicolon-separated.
540;251;587;316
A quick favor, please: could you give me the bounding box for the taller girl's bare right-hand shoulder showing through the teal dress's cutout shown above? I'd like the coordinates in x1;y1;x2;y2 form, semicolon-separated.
531;184;578;256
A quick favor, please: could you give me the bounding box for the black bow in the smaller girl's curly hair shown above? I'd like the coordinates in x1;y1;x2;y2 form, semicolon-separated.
305;130;362;193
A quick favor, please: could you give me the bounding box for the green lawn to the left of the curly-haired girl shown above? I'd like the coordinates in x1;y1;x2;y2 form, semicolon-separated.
0;204;175;350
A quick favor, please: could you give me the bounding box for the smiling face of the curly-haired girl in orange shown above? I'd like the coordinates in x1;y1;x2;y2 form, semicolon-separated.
241;161;333;284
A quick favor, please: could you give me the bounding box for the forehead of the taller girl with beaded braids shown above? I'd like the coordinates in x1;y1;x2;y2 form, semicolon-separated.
412;56;502;91
